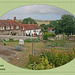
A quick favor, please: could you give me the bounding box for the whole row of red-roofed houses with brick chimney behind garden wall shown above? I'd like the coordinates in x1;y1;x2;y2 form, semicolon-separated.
0;17;41;36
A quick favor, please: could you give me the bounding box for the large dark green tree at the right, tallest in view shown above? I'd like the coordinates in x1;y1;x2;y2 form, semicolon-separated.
55;15;75;37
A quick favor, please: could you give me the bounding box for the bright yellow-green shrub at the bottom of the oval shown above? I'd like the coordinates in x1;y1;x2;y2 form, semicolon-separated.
28;57;55;70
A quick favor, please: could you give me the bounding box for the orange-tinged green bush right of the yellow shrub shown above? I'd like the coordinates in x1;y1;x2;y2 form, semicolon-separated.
42;50;75;67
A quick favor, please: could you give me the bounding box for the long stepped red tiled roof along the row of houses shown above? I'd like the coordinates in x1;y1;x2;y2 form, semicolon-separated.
0;20;40;30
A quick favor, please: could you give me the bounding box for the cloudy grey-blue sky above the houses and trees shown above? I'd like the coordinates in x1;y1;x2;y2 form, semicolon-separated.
0;5;71;20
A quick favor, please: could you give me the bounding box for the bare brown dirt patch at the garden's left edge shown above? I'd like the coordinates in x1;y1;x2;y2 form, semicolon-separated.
0;45;21;61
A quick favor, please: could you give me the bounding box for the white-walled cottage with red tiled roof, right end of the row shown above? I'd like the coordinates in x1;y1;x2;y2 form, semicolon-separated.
22;24;41;36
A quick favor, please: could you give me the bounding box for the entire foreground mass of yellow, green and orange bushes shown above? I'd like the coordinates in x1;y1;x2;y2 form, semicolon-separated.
27;48;75;70
